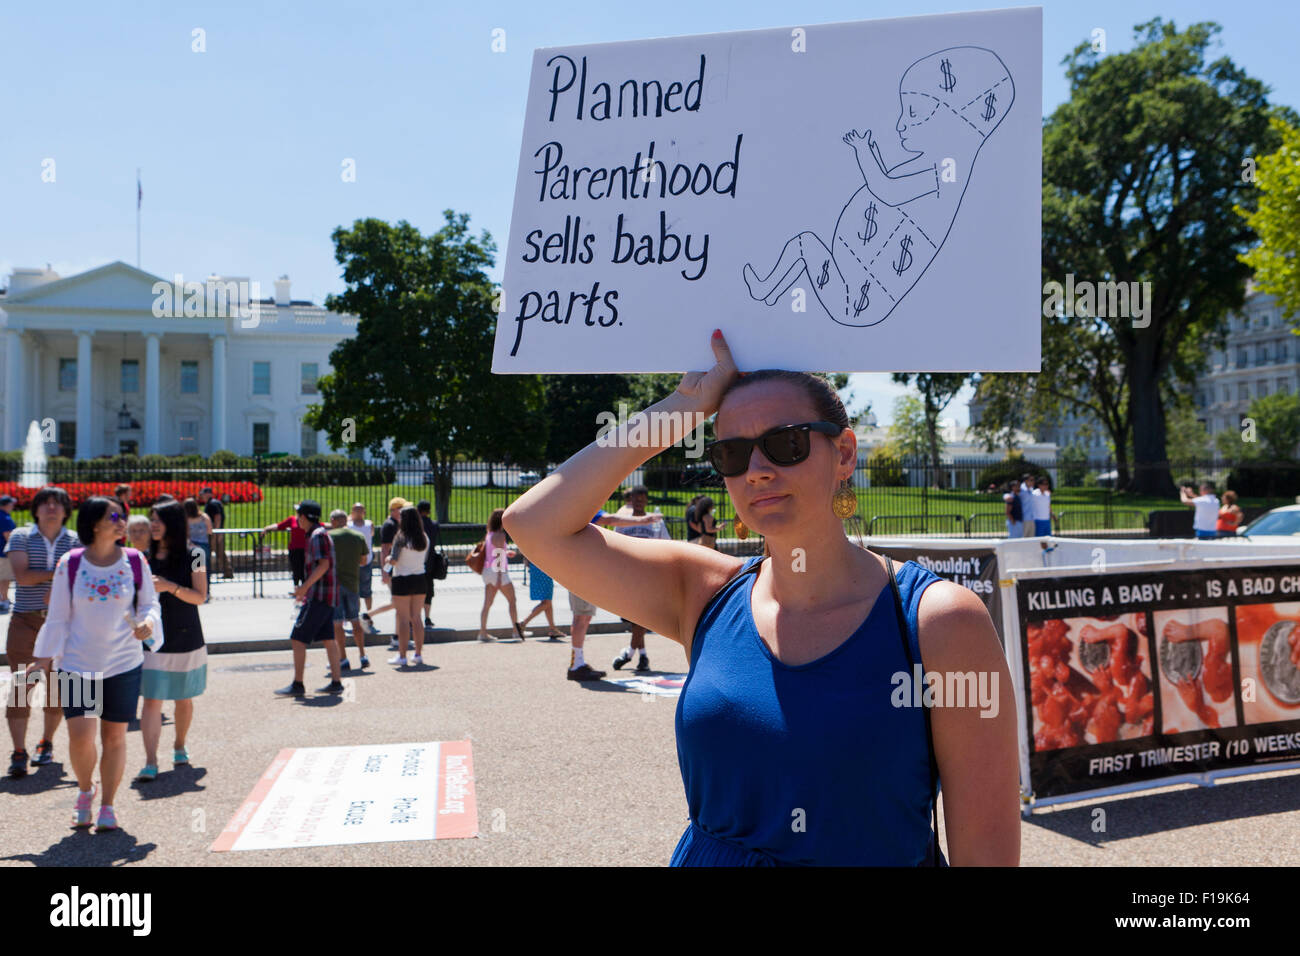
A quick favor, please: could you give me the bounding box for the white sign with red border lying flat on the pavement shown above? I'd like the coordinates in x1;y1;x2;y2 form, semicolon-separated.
209;740;478;851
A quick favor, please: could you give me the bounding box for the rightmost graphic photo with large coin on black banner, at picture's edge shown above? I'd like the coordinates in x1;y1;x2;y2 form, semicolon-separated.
1235;602;1300;723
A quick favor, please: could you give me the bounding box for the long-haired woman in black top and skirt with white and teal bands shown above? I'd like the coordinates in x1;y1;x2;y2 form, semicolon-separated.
135;501;208;780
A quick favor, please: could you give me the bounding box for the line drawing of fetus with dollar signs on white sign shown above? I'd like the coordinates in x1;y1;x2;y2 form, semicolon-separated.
744;47;1015;326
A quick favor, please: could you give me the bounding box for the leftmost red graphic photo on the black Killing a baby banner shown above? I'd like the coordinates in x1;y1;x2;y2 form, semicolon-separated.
1027;613;1156;752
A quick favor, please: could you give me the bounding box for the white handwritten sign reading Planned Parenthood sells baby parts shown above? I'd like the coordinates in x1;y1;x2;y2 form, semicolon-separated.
493;8;1043;373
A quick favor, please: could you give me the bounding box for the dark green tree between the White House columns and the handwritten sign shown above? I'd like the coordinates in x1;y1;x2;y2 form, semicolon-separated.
304;209;547;522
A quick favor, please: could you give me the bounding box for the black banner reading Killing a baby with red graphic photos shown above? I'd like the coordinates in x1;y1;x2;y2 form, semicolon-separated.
1017;567;1300;797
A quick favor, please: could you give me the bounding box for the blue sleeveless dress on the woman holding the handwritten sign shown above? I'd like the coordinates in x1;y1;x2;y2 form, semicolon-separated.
670;558;943;866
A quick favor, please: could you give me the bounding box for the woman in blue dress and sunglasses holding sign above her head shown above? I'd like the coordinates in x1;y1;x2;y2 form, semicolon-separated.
504;332;1021;866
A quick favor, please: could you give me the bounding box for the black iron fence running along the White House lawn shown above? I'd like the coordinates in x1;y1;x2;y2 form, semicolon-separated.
0;451;1300;589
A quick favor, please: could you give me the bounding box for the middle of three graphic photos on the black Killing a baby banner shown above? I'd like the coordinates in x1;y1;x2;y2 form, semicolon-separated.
1152;607;1236;734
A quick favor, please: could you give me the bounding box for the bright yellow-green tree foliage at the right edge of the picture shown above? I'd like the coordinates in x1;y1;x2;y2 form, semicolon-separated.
1236;116;1300;319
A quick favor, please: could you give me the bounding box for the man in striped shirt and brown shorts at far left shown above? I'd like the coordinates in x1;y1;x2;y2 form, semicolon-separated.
5;486;81;777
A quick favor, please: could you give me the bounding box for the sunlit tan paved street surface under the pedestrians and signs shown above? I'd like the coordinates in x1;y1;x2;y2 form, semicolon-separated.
0;567;1300;866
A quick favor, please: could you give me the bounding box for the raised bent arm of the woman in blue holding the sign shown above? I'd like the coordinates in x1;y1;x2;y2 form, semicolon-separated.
504;332;740;643
